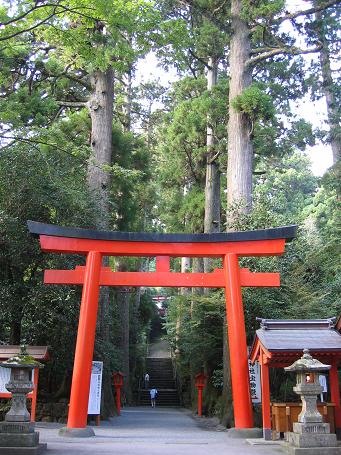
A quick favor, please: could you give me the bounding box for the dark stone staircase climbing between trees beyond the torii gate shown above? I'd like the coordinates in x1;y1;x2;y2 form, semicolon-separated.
139;357;180;407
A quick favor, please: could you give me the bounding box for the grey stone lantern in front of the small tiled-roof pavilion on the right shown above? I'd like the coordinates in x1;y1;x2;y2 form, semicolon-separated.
284;349;341;455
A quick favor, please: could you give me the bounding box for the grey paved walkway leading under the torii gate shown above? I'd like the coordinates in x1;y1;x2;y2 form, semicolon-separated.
37;407;285;455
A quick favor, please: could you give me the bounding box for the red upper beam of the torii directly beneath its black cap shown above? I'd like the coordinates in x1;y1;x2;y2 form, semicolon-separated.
40;235;285;257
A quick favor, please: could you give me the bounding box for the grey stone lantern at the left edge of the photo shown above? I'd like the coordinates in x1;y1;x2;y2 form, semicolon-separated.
0;347;46;455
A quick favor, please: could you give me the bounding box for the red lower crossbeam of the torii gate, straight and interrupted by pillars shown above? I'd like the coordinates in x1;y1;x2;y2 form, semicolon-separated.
44;267;280;288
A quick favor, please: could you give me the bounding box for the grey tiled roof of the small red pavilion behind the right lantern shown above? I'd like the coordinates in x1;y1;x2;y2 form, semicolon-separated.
250;318;341;363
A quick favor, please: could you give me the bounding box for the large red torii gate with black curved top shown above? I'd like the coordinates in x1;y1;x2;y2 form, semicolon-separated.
28;221;297;435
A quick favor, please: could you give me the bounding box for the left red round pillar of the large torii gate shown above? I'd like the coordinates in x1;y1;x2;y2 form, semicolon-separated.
67;251;102;429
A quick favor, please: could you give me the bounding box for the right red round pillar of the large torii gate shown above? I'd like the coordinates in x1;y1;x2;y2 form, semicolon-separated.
224;253;253;429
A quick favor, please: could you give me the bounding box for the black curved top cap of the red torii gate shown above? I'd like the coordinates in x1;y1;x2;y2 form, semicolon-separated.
27;220;298;243
